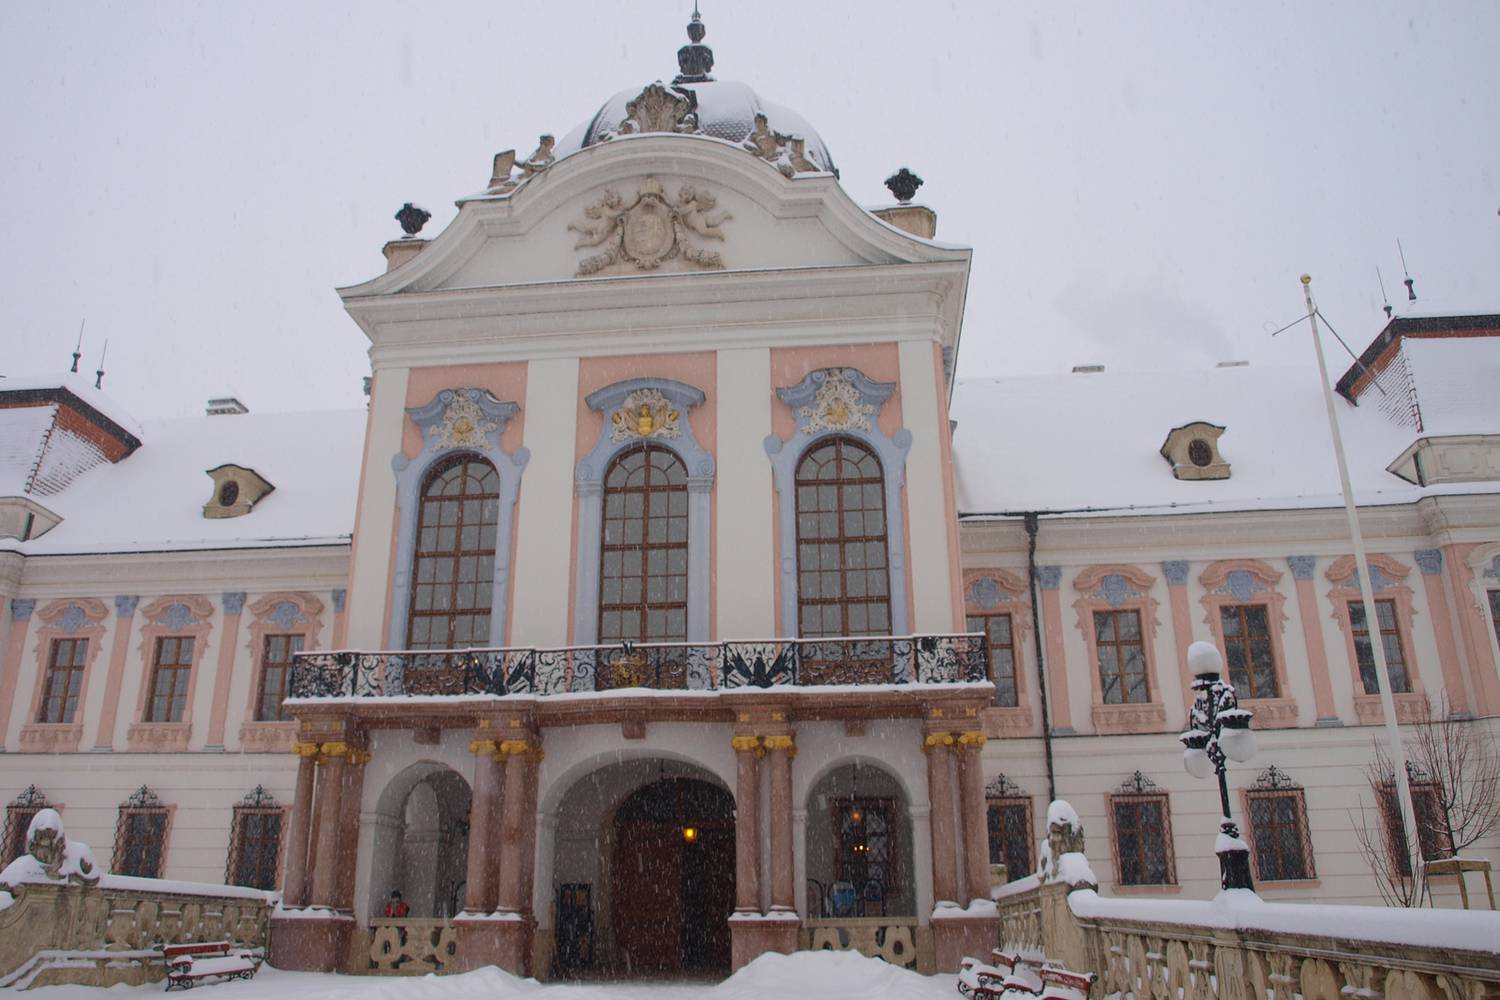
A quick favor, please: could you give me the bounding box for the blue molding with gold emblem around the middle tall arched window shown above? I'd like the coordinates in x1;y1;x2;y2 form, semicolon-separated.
573;378;716;646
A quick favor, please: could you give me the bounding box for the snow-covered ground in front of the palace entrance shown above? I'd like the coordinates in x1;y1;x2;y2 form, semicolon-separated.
27;952;959;1000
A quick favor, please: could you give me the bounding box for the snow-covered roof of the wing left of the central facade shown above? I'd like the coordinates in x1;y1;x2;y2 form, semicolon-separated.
0;409;366;555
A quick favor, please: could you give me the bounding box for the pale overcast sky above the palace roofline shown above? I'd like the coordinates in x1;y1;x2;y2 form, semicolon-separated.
0;0;1500;418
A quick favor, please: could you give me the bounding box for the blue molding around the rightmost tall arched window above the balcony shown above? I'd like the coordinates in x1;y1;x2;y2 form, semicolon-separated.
765;367;912;636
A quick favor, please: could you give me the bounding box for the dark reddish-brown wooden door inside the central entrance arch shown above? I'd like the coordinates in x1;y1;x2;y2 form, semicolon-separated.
611;819;681;976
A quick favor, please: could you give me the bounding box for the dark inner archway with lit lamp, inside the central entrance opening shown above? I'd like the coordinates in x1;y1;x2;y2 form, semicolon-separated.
612;778;735;976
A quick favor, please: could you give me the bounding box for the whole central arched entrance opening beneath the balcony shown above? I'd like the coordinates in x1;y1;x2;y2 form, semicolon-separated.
554;759;735;976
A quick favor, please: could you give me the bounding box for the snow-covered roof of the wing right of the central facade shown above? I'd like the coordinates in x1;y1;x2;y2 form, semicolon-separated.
951;337;1500;514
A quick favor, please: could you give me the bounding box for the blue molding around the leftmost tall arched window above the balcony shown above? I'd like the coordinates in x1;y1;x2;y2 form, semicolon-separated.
386;388;531;649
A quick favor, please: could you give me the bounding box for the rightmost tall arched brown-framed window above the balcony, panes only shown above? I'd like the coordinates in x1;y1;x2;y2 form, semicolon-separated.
797;438;891;639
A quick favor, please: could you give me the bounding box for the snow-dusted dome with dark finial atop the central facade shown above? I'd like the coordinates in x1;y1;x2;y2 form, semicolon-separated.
557;10;839;175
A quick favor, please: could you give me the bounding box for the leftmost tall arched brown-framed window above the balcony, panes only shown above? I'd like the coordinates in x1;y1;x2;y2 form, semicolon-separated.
407;453;500;649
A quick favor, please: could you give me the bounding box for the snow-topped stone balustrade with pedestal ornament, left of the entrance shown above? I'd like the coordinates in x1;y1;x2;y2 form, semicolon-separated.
0;810;275;988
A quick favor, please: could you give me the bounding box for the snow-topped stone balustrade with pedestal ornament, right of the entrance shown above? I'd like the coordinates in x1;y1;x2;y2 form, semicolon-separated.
993;802;1500;1000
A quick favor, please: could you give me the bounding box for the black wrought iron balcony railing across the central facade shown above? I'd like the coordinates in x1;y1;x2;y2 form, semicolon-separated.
288;633;990;699
